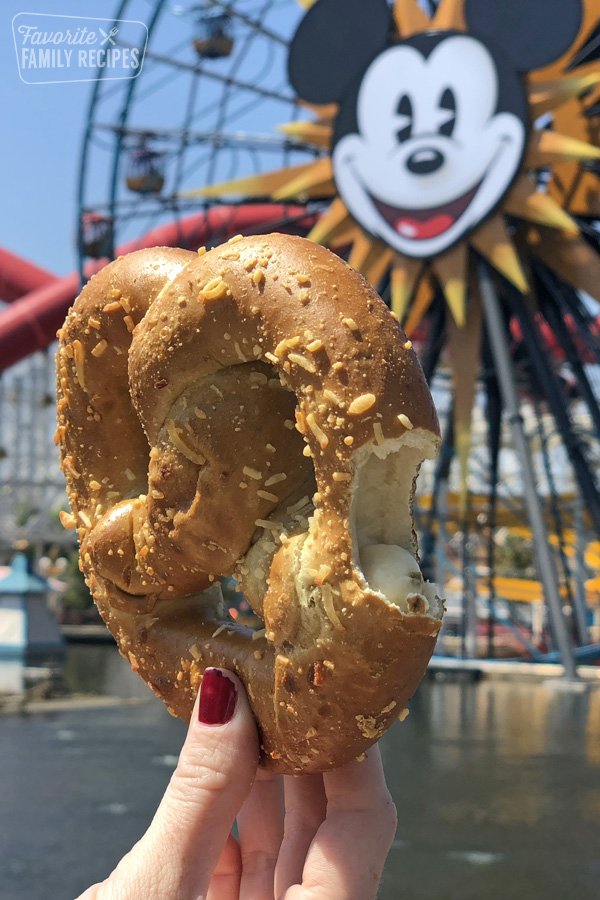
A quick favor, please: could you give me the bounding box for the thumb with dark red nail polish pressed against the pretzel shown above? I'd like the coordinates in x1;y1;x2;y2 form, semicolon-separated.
114;668;259;900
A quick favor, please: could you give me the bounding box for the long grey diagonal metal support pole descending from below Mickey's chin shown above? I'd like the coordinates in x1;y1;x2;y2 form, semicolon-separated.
478;260;578;680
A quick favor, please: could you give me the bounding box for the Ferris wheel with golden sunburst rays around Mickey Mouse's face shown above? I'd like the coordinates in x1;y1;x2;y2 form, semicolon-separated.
78;0;600;655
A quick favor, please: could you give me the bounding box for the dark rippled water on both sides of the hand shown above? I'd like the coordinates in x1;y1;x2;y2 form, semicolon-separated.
0;646;600;900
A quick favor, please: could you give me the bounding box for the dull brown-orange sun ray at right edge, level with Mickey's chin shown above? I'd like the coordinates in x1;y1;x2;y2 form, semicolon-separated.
527;227;600;300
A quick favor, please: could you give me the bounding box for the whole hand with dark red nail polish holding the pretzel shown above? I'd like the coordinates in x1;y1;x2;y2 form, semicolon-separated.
79;669;396;900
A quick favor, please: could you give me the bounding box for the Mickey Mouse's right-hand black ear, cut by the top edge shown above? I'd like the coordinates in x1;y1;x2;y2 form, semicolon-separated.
465;0;582;72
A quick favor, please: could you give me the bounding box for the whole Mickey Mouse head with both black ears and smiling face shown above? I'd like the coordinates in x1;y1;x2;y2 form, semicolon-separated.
288;0;581;257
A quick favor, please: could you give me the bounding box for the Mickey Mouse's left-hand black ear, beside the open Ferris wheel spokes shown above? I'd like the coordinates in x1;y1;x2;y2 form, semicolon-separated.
288;0;392;103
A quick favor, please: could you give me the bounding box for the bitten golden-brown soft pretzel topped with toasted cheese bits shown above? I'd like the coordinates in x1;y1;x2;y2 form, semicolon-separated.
57;234;442;773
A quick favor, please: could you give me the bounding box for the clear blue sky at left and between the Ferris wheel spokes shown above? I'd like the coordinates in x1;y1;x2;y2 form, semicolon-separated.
0;0;302;274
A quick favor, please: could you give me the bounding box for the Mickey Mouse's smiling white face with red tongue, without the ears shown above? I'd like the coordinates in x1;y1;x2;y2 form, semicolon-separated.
333;34;526;257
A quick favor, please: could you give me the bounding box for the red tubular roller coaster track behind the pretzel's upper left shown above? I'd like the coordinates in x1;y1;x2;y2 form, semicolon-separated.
0;204;314;372
